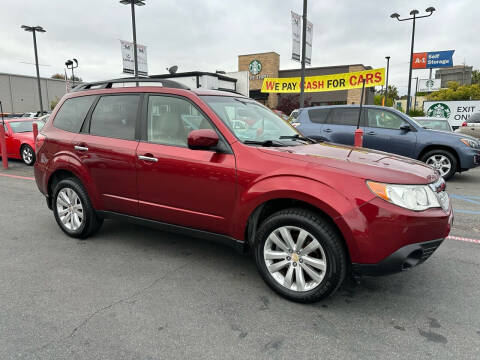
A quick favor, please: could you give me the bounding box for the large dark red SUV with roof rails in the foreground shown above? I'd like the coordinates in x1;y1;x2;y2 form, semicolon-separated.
35;80;453;302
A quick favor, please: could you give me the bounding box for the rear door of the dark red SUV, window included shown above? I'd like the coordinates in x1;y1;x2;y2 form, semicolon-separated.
73;94;141;216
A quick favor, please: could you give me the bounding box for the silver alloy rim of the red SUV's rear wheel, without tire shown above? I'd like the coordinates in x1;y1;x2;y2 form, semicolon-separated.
56;188;85;231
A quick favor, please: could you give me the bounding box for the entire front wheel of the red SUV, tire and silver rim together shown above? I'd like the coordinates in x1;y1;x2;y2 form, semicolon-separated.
255;208;347;303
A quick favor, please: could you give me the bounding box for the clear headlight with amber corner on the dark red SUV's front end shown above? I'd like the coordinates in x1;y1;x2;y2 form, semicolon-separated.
367;181;442;211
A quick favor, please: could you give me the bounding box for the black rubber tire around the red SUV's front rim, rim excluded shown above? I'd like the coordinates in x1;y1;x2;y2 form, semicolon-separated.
254;208;347;303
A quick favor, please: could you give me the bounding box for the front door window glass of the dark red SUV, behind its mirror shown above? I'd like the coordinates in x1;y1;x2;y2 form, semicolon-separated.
147;95;213;147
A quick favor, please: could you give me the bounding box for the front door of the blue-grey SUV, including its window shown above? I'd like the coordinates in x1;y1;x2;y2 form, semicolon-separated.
363;108;417;157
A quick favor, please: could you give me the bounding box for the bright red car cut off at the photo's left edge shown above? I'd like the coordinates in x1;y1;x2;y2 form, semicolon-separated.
0;118;45;166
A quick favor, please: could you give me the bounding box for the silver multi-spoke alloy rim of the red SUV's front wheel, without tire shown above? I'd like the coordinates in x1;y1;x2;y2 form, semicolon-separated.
263;226;327;291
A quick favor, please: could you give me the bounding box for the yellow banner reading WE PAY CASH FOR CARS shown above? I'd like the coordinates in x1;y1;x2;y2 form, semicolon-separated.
262;68;385;93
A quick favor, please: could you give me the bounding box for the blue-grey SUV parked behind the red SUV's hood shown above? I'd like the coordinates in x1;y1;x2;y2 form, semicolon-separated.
292;105;480;179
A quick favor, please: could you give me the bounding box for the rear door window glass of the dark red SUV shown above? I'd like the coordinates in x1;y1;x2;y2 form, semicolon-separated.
90;95;140;140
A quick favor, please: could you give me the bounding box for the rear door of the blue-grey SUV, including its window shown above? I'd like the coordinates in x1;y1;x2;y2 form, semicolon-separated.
322;107;362;145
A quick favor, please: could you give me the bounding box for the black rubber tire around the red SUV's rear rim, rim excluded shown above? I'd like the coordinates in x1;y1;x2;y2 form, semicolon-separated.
52;178;103;239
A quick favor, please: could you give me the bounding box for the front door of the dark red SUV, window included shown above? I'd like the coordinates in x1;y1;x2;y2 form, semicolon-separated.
137;94;236;234
